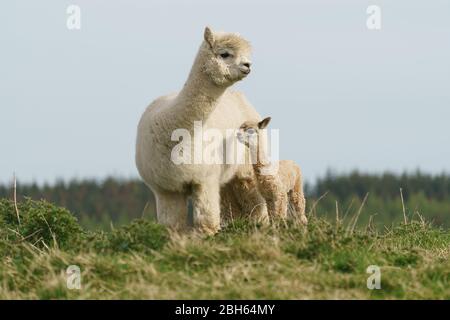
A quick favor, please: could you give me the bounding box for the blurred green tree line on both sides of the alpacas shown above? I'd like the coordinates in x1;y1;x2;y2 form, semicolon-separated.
0;171;450;230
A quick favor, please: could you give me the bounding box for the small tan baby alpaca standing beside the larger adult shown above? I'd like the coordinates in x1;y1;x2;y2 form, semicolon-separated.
237;117;308;224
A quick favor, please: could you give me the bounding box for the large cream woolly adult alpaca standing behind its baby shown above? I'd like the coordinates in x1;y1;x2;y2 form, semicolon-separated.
136;27;267;234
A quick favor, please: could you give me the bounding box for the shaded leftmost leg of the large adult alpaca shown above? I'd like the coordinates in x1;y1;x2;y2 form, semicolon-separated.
155;192;188;230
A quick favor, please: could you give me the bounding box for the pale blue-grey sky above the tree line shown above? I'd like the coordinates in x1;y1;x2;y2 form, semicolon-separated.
0;0;450;183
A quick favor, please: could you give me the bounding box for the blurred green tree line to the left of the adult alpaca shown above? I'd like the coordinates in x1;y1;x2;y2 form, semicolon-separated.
0;178;154;230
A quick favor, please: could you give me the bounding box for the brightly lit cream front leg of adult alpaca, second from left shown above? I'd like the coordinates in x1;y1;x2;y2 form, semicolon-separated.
192;183;220;234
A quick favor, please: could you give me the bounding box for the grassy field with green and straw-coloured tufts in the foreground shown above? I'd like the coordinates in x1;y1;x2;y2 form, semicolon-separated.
0;200;450;299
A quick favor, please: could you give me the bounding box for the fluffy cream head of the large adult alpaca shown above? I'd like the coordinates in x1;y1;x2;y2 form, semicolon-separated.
202;27;251;87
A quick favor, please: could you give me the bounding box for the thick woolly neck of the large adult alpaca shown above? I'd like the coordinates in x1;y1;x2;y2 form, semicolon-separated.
177;44;227;125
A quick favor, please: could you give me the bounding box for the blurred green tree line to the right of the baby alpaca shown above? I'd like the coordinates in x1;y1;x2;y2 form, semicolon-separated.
306;171;450;228
